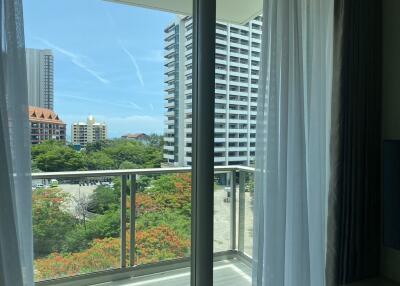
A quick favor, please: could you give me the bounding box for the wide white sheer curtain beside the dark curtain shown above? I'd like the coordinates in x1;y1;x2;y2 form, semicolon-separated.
253;0;333;286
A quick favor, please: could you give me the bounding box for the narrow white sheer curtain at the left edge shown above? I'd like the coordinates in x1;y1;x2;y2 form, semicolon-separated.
0;0;34;286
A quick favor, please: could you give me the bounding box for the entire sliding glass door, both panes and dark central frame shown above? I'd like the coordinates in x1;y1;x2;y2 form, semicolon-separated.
24;0;262;286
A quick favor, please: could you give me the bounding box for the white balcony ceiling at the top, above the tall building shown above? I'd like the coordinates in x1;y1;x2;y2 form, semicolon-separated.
108;0;263;24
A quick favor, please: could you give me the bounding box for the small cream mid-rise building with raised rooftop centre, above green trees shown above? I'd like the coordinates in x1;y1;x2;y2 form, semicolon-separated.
71;115;107;148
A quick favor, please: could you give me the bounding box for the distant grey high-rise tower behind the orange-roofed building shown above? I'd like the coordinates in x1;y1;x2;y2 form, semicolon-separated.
26;49;54;110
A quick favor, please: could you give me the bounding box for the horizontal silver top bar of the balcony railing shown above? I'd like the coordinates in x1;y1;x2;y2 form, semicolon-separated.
32;165;254;180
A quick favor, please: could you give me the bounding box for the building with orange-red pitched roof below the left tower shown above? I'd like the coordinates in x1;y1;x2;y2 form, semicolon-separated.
29;106;66;144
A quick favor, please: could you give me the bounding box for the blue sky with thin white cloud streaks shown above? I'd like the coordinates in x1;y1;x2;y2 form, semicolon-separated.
23;0;175;138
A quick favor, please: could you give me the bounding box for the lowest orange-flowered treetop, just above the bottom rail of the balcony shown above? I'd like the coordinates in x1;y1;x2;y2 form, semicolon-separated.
35;226;190;280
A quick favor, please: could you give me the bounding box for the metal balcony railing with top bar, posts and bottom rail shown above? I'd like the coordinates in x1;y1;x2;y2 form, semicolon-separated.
32;166;254;285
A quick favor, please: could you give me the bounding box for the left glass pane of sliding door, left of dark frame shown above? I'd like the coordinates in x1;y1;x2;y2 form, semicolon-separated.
23;0;196;285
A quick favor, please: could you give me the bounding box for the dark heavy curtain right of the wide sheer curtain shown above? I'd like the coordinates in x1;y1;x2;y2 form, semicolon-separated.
326;0;381;285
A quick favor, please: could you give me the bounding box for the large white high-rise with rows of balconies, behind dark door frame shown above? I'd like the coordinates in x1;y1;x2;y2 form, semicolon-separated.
164;16;262;166
